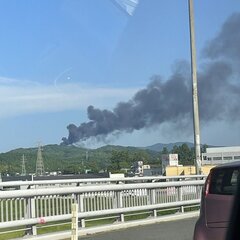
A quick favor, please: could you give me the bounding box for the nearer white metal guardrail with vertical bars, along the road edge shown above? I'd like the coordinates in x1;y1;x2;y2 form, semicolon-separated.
0;179;204;239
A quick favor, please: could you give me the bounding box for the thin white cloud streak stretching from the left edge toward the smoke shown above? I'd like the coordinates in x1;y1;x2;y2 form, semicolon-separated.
0;77;138;118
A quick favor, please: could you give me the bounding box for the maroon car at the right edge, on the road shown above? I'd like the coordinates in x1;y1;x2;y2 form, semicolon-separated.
193;161;240;240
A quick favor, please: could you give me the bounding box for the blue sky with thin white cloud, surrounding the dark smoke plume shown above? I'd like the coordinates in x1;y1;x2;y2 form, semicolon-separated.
0;0;240;152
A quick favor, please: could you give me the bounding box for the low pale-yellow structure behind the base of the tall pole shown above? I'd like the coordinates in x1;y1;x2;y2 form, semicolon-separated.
166;165;216;176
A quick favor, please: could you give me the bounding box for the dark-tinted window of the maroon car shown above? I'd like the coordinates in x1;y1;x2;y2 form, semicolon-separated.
209;168;239;195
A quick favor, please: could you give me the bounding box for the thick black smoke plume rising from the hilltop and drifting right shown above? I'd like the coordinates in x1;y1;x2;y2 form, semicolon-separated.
62;13;240;144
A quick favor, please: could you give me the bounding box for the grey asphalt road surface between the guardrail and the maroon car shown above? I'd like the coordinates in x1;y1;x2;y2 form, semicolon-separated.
79;218;197;240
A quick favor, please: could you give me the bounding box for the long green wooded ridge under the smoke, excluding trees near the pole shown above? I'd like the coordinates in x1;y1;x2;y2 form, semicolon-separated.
0;144;158;174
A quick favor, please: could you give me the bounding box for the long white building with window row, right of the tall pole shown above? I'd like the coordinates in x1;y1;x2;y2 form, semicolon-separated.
202;146;240;165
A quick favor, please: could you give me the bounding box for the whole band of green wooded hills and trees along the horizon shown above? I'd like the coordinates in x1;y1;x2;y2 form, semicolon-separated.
0;143;208;175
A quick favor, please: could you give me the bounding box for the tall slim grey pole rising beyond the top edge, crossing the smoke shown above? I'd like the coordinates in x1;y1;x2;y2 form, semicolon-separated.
188;0;201;174
